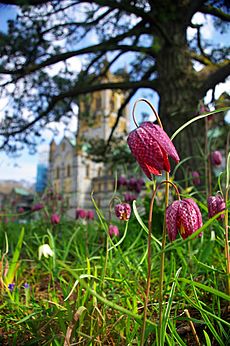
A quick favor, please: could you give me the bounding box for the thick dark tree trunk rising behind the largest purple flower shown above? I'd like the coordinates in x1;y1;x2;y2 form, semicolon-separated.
156;12;205;174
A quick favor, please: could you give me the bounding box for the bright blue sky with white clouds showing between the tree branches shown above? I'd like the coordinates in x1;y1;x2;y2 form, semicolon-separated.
0;6;230;183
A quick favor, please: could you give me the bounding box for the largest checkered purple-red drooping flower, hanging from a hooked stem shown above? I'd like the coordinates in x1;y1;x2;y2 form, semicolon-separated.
127;121;180;180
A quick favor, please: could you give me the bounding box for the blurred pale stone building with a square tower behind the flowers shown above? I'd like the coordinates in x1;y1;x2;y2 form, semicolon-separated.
48;72;128;216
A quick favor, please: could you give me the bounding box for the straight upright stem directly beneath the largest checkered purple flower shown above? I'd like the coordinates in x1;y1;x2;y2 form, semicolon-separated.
158;172;169;346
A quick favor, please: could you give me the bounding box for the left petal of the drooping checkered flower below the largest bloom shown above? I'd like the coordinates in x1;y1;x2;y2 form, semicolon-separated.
166;201;180;241
